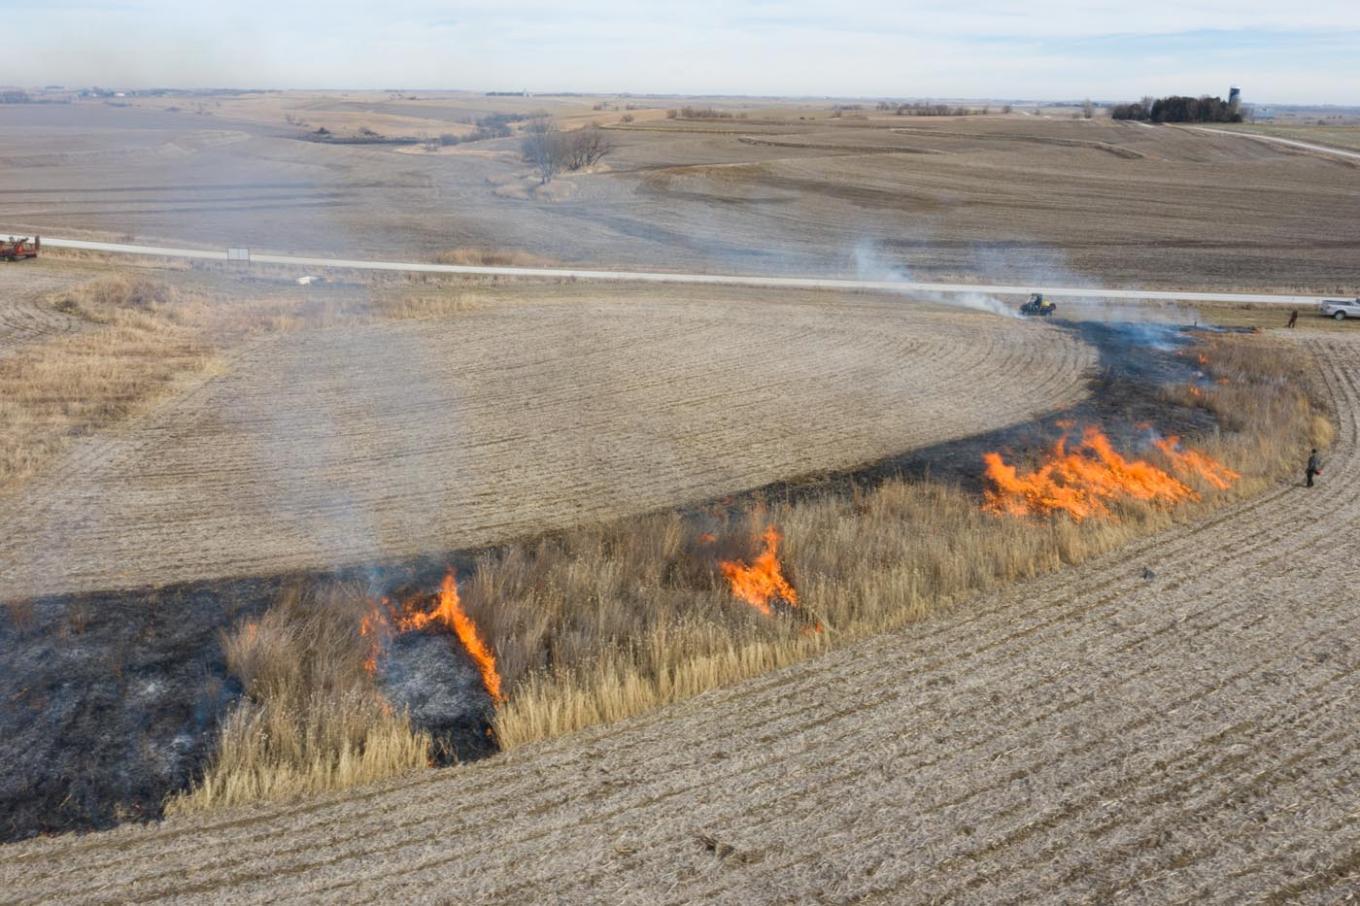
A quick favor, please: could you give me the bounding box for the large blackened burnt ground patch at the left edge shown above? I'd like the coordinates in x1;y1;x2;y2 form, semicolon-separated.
0;584;272;842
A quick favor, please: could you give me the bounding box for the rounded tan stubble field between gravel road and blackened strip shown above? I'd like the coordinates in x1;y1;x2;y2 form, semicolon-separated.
0;295;1093;597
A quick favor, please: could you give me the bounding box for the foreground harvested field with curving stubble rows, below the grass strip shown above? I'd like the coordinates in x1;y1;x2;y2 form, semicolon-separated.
0;332;1360;905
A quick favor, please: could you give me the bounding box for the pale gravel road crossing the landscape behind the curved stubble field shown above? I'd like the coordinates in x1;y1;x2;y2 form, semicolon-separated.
26;237;1322;305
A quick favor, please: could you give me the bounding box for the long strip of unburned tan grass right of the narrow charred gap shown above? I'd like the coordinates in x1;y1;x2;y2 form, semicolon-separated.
489;330;1333;748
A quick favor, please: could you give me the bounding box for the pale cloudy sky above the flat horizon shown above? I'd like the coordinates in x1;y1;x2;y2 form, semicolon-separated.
0;0;1360;105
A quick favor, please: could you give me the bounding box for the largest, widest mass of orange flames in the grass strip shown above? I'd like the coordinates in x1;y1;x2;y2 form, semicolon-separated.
982;426;1198;522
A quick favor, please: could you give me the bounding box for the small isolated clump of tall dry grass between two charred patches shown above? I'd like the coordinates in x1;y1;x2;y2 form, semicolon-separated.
166;586;431;813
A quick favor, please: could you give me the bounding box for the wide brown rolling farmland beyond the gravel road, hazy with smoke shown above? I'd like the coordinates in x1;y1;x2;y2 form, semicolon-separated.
0;95;1360;292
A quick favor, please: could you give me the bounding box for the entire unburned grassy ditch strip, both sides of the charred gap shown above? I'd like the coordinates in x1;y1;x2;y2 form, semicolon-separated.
173;327;1331;811
